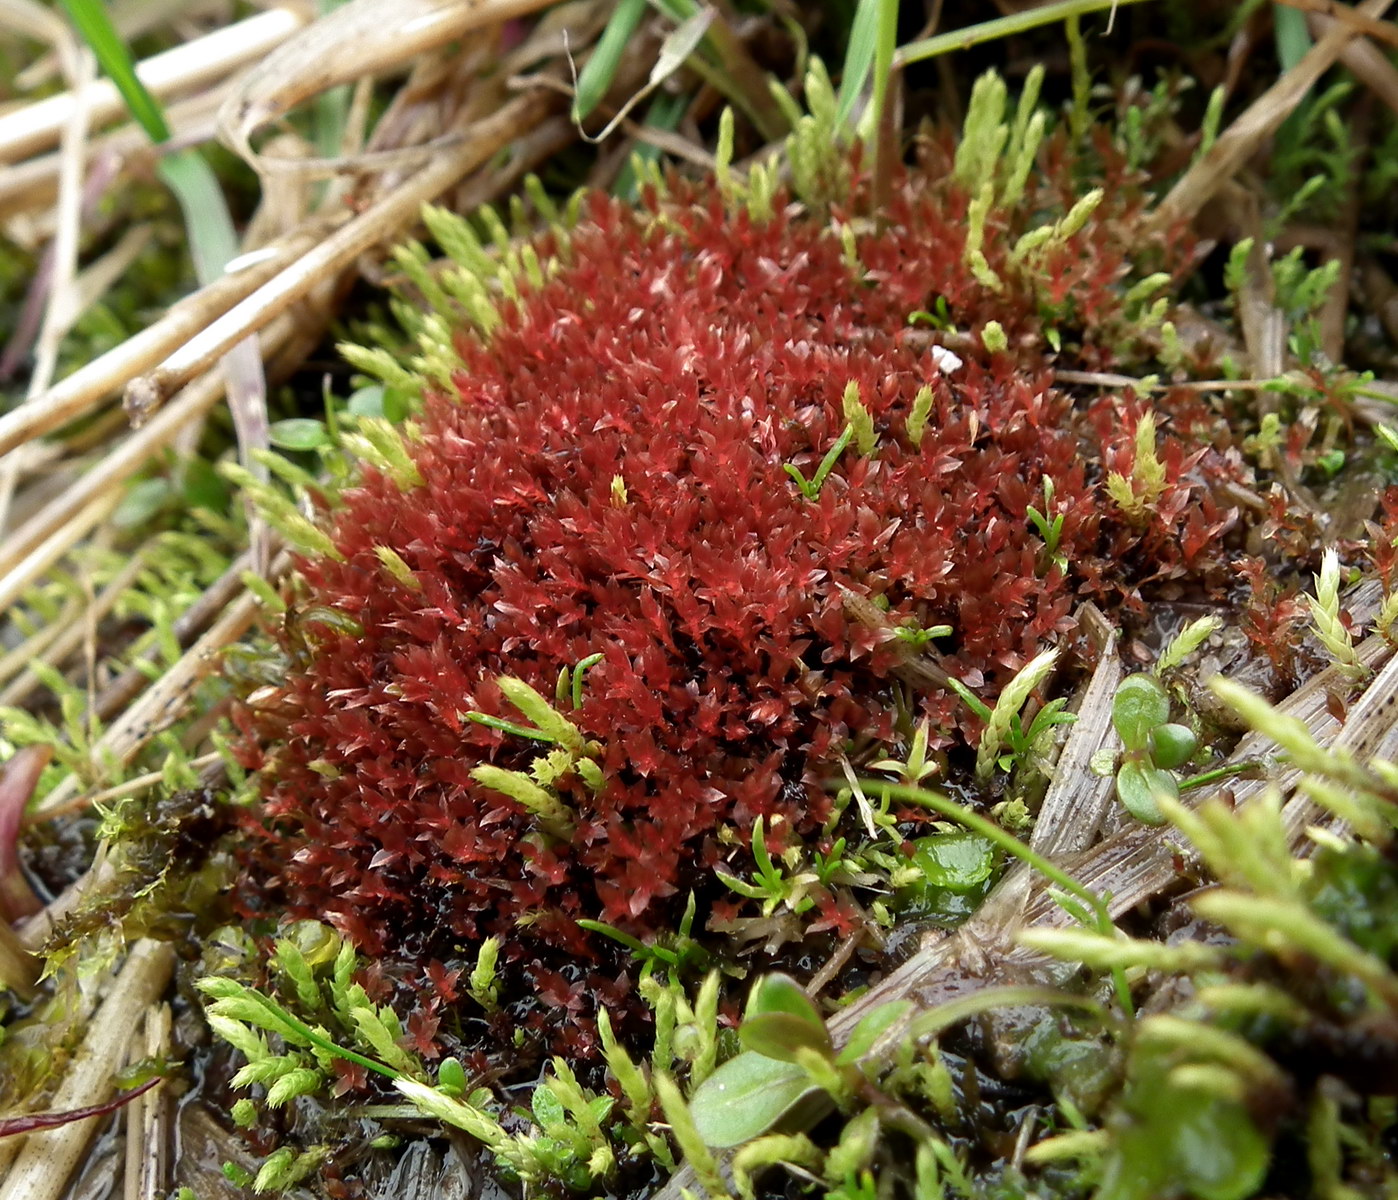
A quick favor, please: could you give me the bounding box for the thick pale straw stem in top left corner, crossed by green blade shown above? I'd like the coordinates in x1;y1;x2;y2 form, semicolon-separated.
0;6;308;164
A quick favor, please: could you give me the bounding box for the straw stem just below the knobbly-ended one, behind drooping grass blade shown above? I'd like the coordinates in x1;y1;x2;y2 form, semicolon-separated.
0;310;292;610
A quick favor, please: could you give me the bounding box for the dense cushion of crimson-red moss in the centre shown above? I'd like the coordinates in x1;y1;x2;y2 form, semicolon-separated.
234;163;1240;1041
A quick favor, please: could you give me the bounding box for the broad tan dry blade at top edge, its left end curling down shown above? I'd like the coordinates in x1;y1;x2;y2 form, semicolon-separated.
218;0;551;169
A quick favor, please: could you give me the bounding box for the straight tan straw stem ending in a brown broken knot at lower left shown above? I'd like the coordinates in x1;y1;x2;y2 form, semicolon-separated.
123;92;556;416
